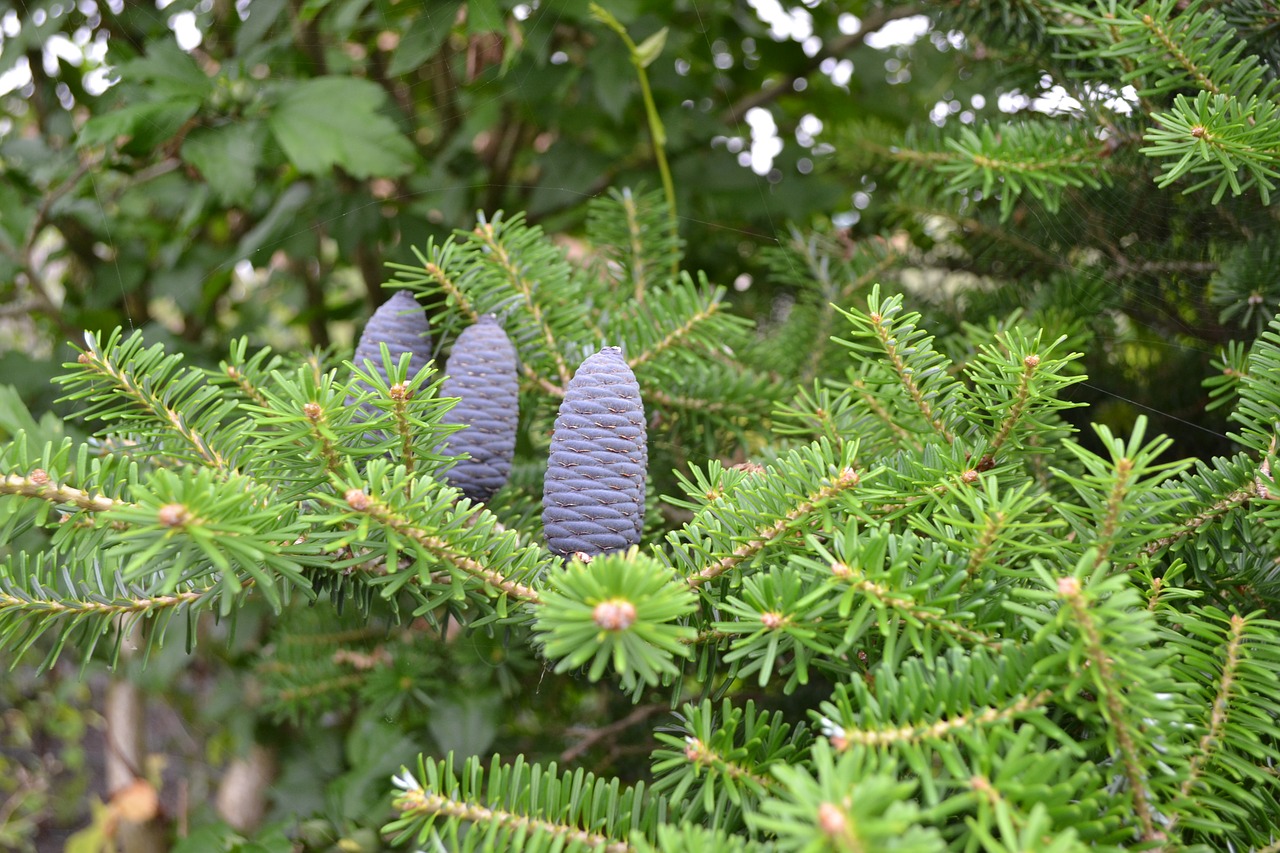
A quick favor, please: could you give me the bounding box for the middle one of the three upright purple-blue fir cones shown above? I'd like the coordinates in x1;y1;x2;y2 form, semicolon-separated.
440;314;520;501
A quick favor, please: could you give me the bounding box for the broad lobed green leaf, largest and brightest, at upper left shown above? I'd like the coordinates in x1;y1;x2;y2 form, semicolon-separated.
268;77;417;178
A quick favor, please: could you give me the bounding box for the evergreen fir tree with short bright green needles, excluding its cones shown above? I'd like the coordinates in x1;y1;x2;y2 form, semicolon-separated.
0;0;1280;850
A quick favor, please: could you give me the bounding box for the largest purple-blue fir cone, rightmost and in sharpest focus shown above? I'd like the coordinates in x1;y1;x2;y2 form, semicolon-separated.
543;347;649;557
